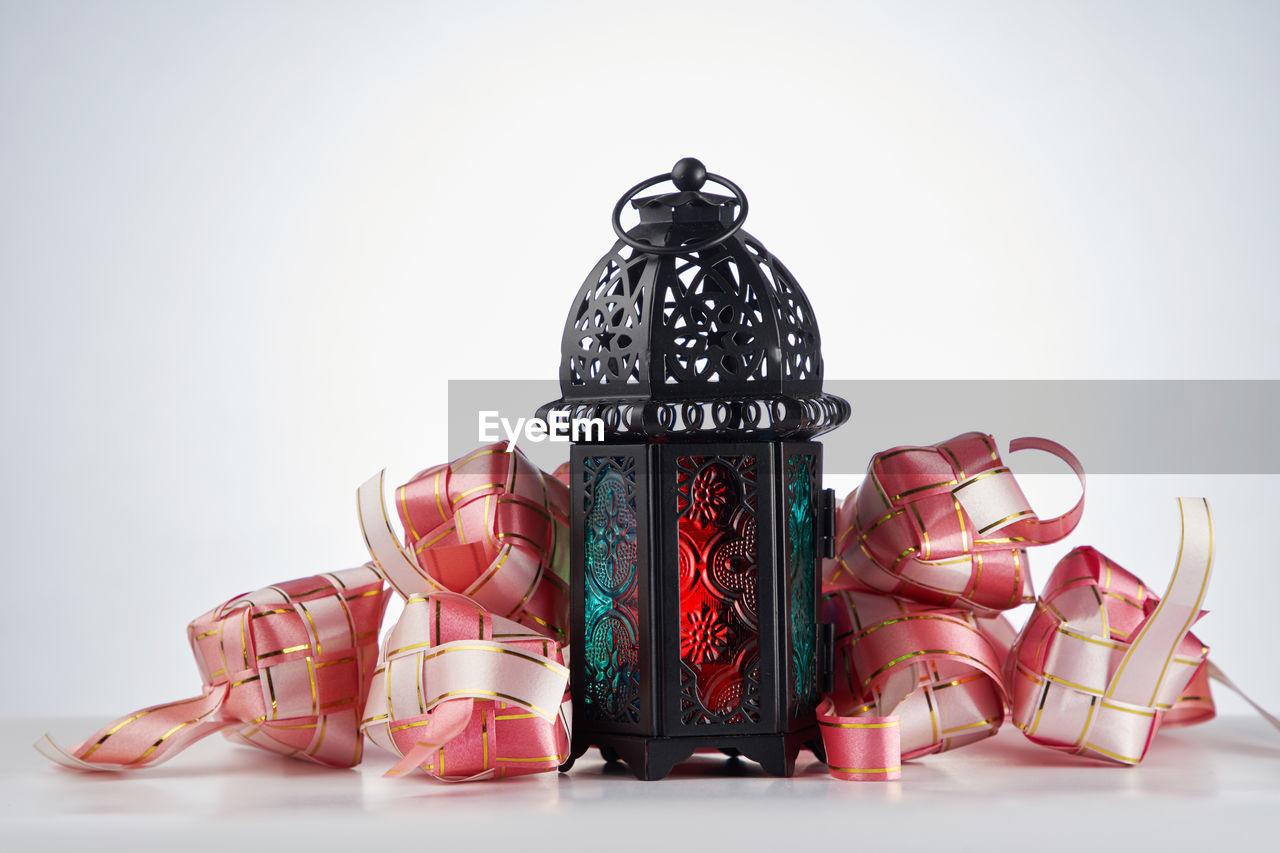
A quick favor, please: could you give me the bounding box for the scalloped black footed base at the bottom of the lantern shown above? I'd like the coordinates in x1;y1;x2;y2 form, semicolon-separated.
559;726;826;781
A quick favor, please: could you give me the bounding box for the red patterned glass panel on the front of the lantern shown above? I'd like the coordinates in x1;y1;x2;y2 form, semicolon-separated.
676;456;760;725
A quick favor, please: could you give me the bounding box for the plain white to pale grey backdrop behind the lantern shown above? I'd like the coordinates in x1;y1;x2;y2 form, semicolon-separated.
0;0;1280;739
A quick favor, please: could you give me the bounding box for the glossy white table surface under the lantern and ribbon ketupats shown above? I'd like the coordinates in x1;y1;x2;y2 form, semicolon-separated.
0;717;1280;853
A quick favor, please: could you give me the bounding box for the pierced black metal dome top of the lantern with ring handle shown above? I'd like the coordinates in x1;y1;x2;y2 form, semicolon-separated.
539;158;849;441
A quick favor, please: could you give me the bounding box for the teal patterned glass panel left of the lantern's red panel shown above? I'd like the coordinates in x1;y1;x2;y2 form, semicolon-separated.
581;456;640;722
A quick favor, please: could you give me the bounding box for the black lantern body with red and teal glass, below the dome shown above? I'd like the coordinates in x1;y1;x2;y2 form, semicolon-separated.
571;442;823;779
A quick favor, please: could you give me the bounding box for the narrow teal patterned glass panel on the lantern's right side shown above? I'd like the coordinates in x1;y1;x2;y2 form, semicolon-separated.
787;455;818;716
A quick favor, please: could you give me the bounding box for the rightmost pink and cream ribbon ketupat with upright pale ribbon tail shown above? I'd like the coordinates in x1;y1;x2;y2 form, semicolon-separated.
1009;498;1213;765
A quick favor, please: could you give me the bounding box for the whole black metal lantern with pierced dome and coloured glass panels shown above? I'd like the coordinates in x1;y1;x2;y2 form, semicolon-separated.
539;158;849;779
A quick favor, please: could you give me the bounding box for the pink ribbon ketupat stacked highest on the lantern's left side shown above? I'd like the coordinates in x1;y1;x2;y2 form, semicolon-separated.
357;442;570;642
